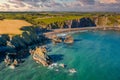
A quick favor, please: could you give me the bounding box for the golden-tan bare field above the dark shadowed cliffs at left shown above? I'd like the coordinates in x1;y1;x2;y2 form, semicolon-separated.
0;19;32;34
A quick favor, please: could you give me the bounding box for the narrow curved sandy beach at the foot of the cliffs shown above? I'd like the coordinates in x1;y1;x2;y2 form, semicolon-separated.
44;27;120;39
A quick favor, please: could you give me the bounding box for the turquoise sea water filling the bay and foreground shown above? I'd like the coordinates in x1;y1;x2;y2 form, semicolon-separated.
0;31;120;80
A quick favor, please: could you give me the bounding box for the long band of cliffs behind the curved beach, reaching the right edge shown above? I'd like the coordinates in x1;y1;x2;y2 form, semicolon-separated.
47;15;120;29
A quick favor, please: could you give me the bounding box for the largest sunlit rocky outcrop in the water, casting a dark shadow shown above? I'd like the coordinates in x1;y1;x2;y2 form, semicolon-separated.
30;47;52;66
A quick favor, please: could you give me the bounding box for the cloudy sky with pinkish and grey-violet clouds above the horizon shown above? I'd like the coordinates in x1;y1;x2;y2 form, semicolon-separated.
0;0;120;12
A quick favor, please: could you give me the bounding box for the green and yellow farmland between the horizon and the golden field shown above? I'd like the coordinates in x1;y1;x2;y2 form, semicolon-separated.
0;12;91;27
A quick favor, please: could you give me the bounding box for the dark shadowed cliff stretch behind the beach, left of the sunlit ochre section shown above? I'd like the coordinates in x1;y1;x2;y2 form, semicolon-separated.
49;18;96;29
